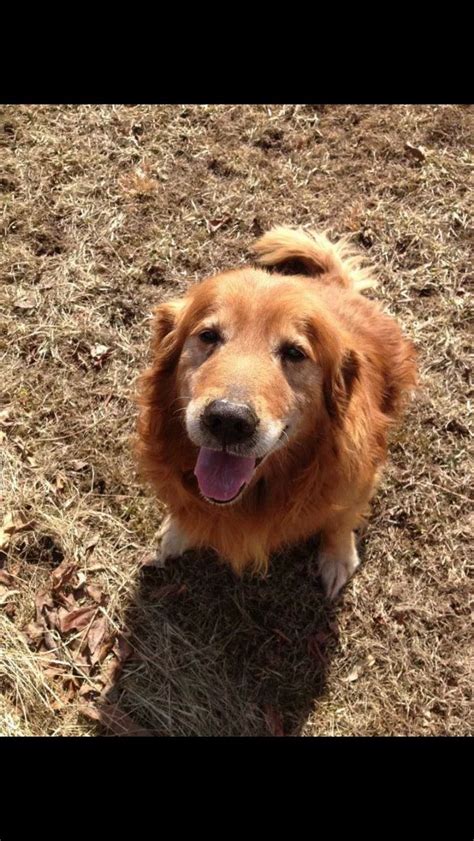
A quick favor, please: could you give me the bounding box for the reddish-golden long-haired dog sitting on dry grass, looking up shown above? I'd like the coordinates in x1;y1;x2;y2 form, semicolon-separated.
137;227;416;599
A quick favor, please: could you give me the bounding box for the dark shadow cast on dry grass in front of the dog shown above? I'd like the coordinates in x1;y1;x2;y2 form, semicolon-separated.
106;541;338;736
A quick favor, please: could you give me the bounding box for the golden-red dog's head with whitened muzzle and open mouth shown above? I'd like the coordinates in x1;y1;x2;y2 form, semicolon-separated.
150;269;357;504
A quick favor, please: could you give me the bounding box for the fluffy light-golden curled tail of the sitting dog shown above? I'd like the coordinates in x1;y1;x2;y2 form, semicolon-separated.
252;227;376;292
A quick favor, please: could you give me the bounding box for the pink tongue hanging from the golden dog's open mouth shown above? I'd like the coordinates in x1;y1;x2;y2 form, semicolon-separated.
194;447;255;502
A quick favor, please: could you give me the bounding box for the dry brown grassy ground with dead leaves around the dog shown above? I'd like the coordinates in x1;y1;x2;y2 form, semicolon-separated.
0;105;473;735
